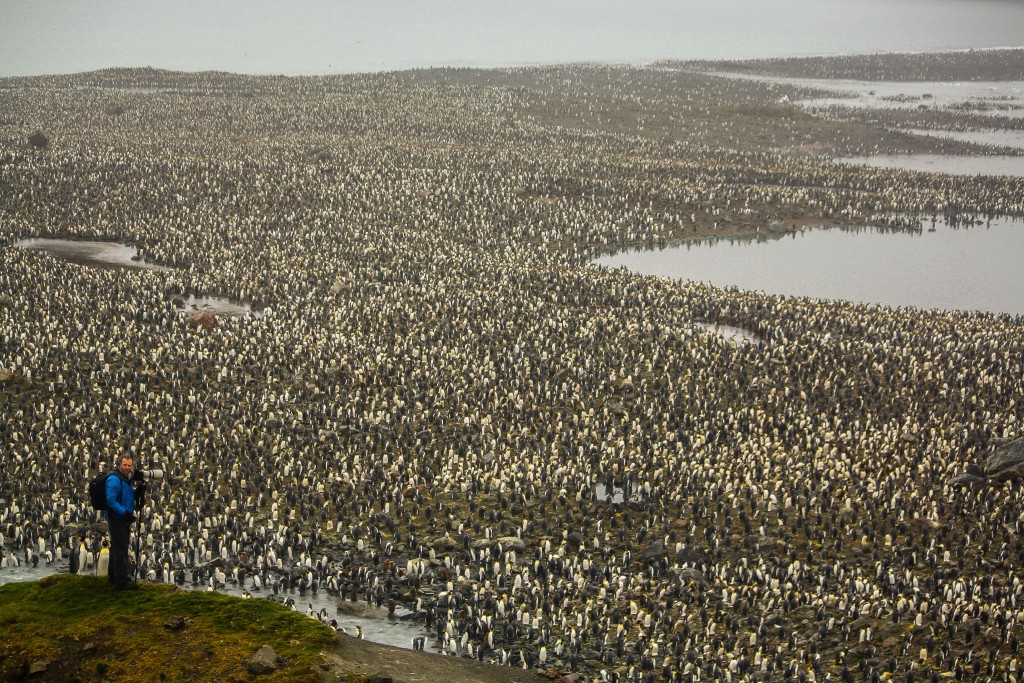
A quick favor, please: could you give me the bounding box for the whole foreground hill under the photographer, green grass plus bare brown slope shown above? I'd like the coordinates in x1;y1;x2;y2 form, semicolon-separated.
0;574;545;683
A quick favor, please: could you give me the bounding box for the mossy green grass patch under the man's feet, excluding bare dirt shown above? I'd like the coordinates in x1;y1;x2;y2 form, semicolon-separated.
0;574;334;682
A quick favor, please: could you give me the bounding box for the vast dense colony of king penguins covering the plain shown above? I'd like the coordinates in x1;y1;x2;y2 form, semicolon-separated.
0;49;1024;681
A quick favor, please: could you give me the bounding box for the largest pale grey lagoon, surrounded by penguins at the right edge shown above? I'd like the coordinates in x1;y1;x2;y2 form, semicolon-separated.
596;219;1024;315
